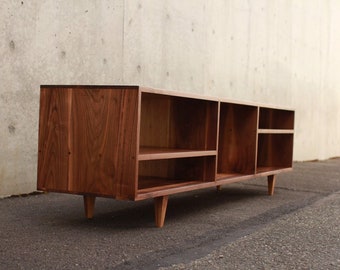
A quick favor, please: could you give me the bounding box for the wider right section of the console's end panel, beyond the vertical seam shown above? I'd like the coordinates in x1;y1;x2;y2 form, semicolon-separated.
69;88;138;198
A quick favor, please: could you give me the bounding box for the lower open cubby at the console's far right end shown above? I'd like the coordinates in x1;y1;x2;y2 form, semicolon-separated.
256;134;293;173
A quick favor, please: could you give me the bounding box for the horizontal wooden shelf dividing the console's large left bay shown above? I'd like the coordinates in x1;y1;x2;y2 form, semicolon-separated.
138;147;217;160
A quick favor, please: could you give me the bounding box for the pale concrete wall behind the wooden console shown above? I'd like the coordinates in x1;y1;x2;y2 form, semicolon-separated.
0;0;340;196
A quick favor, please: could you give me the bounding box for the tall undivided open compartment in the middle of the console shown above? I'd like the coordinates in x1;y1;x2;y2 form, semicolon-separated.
216;102;258;180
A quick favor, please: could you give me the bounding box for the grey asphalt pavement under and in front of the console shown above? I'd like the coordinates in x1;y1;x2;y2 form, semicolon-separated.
0;159;340;270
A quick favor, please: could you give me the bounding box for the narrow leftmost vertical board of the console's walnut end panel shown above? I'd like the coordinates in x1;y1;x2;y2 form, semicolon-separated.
37;87;71;192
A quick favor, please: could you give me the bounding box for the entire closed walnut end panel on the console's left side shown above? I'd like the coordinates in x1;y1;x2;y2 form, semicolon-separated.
38;86;139;199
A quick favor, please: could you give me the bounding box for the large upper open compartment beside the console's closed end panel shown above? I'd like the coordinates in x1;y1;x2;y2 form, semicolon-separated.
139;92;218;160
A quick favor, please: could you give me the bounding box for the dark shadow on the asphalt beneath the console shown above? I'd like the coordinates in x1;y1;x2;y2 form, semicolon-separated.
51;186;267;230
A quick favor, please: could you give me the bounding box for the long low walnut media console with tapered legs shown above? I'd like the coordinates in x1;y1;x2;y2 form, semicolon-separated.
37;85;294;227
